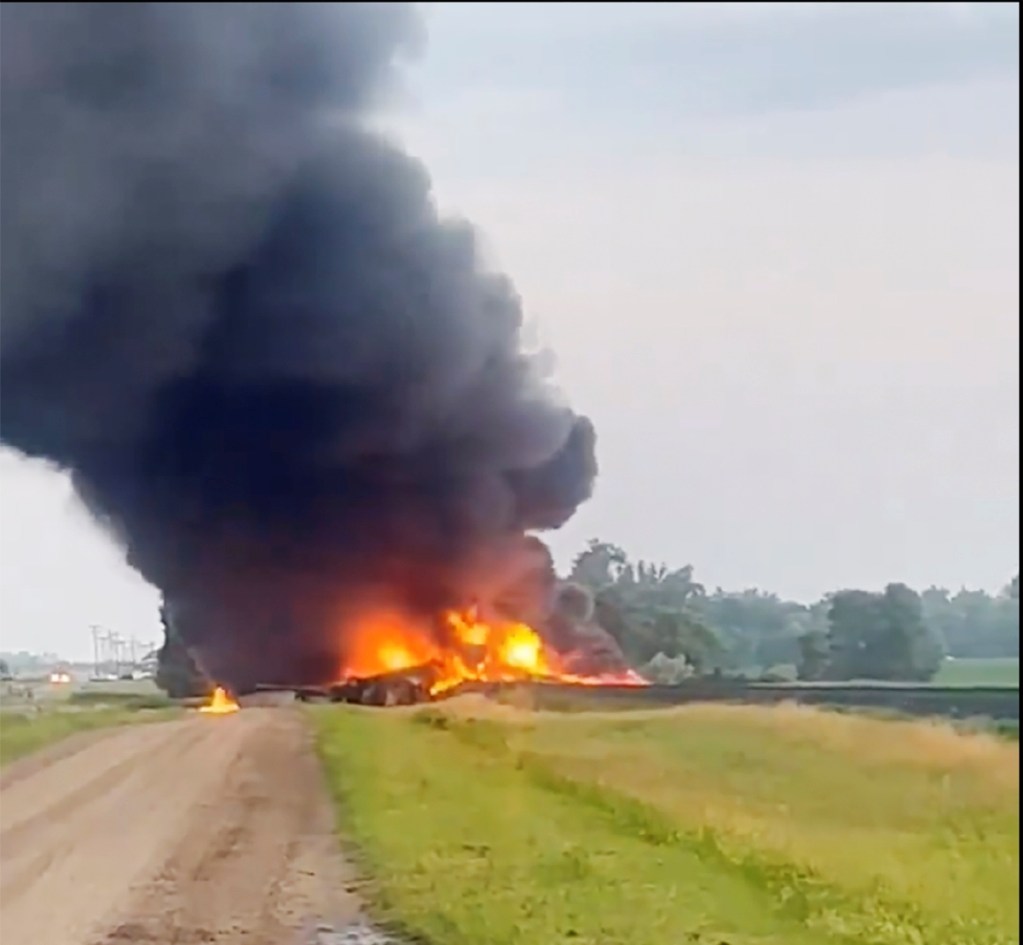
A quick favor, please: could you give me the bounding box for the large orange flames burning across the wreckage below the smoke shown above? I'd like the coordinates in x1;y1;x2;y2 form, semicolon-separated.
342;608;647;695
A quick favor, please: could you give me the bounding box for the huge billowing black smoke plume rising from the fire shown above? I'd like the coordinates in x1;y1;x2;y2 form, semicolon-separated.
0;3;595;685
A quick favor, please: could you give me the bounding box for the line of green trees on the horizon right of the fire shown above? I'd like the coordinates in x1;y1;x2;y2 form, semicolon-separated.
569;539;1019;682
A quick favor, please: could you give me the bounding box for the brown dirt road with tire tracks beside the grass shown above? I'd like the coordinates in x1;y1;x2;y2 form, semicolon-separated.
0;708;366;945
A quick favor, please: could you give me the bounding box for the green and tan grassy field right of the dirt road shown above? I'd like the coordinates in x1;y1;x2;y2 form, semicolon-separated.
311;698;1019;945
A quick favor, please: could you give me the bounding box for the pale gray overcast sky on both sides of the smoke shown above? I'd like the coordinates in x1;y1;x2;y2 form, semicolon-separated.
0;3;1019;657
